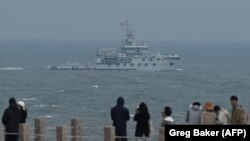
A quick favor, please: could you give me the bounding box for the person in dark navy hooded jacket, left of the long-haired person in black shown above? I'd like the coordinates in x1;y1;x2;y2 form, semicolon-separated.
111;97;130;141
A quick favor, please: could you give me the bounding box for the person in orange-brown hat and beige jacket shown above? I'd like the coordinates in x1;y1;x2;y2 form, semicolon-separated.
201;102;216;125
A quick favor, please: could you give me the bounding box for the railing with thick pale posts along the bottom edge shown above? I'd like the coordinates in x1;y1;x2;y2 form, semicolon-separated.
0;119;165;141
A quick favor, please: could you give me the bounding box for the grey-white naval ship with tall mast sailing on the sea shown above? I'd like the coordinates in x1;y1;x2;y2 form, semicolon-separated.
49;21;180;71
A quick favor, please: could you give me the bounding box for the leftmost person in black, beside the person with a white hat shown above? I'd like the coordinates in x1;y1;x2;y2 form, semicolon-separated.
2;97;21;141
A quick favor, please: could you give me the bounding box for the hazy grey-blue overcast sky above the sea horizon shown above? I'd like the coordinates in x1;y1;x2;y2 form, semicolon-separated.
0;0;250;41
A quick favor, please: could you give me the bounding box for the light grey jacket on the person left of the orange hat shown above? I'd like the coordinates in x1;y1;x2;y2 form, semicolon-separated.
186;105;202;125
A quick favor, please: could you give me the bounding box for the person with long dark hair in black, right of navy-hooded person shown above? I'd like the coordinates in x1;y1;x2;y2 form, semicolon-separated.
134;102;150;137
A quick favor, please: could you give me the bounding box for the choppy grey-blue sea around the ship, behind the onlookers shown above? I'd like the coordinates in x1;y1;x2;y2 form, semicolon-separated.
0;40;250;140
